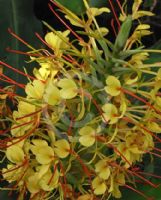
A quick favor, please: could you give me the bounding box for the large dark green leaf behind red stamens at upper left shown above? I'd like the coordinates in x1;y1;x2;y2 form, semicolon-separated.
0;0;42;92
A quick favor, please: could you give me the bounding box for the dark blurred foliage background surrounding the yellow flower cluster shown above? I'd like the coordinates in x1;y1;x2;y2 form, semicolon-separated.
0;0;161;200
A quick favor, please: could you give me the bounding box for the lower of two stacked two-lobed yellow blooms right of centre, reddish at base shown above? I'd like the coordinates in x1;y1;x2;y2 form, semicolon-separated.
102;103;120;124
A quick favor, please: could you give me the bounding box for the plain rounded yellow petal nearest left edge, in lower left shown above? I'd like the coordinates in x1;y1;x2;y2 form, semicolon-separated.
6;145;25;164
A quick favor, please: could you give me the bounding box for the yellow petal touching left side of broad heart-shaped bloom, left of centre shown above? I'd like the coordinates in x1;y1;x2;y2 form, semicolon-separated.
43;83;61;106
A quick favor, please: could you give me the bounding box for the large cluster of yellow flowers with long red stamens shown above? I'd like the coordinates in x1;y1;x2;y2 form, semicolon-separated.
1;0;161;200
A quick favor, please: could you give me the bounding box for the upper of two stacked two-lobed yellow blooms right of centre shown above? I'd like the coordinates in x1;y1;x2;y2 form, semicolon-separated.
105;76;121;96
